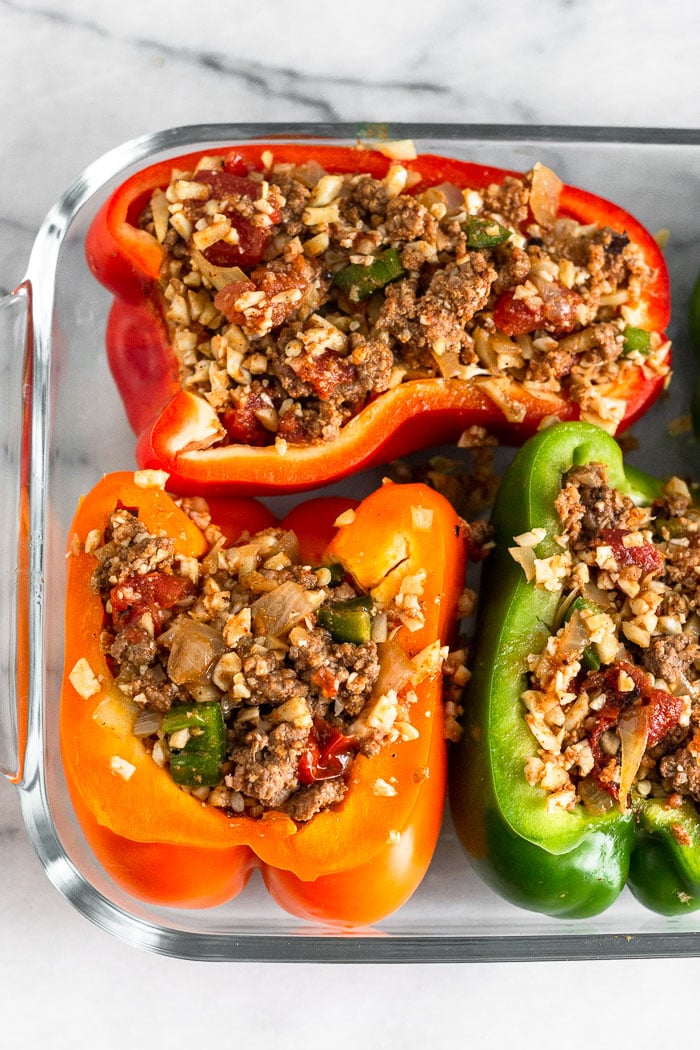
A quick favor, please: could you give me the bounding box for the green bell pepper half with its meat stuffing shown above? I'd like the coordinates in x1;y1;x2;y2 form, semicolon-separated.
450;422;700;918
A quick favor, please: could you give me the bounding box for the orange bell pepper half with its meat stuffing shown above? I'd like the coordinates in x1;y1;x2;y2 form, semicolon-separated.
61;470;467;924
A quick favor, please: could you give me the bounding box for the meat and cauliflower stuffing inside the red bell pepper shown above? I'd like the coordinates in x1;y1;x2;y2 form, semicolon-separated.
141;144;669;450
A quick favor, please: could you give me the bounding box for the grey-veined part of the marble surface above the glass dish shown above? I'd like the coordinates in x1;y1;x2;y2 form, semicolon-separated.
0;0;700;288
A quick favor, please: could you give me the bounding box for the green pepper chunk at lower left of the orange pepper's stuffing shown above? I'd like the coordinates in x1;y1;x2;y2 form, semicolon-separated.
162;700;226;788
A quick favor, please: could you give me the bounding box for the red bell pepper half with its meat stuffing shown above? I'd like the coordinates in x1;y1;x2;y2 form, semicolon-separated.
87;142;670;495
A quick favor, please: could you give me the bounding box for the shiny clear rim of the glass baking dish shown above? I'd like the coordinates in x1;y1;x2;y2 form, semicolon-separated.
17;122;700;963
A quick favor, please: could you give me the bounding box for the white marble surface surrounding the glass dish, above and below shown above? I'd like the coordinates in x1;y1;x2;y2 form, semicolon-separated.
0;0;700;1050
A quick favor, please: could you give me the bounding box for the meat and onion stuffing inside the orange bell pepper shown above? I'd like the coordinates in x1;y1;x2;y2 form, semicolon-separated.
91;498;465;821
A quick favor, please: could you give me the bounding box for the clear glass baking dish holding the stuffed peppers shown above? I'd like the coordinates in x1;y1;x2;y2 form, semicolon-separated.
0;124;700;963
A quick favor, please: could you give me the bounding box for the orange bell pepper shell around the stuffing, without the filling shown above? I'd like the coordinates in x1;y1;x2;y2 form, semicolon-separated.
60;474;466;924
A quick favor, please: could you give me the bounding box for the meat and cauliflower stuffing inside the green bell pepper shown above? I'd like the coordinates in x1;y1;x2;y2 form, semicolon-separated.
512;464;700;812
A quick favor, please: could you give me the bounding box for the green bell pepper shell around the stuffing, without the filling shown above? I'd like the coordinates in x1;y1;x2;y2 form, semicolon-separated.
450;423;700;918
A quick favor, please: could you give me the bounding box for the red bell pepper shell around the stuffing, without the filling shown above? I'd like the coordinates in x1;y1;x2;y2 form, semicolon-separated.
86;143;670;495
